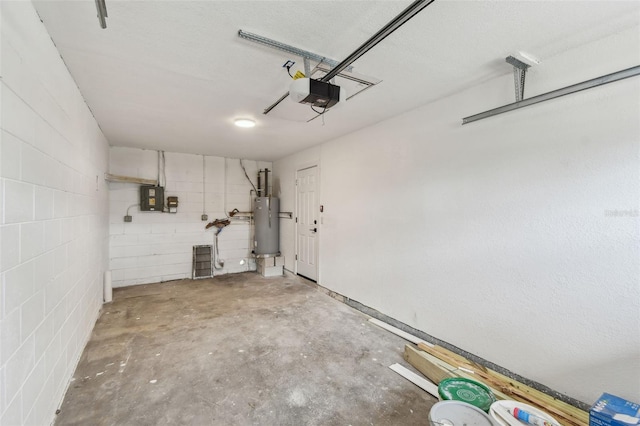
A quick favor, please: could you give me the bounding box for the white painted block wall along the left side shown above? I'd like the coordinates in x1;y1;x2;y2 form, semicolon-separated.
0;1;108;425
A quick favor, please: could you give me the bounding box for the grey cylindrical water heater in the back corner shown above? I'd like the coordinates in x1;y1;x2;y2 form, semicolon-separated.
253;169;280;258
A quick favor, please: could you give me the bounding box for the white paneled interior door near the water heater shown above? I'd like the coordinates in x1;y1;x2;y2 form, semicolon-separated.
296;166;320;281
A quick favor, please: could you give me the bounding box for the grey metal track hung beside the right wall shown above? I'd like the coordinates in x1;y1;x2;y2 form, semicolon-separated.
462;65;640;125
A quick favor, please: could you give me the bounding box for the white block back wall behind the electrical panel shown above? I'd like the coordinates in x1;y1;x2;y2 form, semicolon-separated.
109;147;271;287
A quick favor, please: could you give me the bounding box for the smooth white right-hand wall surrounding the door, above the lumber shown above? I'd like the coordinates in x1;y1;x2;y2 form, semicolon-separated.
274;27;640;404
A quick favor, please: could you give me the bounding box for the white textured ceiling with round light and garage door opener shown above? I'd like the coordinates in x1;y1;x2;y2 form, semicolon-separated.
34;0;640;160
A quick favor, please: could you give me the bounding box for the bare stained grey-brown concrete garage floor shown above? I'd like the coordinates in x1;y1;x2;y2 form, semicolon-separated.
55;273;436;425
